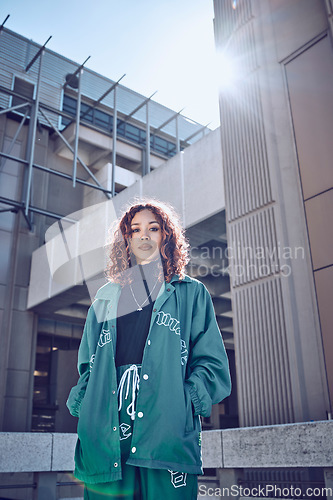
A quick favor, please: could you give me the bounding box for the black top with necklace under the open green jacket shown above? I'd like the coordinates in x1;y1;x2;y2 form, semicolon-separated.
116;261;162;366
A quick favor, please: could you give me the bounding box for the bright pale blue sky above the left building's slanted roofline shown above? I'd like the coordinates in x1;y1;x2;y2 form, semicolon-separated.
0;0;219;129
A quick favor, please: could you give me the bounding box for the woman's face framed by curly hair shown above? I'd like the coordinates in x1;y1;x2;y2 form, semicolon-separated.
129;208;162;264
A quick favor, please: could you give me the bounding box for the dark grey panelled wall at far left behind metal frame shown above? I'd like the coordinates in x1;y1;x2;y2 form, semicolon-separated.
0;115;82;431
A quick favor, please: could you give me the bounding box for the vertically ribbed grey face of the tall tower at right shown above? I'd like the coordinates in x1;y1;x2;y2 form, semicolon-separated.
215;0;333;425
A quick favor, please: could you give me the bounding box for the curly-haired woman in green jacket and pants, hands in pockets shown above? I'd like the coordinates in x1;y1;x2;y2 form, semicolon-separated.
67;200;231;500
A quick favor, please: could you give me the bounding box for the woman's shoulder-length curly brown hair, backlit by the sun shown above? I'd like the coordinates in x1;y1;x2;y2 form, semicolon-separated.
106;198;189;285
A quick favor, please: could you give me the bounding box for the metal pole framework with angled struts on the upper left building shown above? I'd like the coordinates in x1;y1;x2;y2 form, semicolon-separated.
0;26;207;230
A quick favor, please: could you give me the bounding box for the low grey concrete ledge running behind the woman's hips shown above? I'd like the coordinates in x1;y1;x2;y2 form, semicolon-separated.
0;420;333;473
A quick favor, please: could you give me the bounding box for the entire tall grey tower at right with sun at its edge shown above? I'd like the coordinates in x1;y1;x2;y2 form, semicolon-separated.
214;0;333;426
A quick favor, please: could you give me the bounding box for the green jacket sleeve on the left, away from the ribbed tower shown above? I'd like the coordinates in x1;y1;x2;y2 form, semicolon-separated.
66;306;96;417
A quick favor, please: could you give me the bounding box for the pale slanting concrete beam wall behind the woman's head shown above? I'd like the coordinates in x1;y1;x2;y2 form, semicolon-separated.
28;130;224;308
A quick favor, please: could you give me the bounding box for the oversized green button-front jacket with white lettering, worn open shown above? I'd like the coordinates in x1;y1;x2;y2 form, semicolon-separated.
67;275;231;483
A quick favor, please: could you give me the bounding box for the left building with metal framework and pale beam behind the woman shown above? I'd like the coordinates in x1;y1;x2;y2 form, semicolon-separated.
0;27;238;442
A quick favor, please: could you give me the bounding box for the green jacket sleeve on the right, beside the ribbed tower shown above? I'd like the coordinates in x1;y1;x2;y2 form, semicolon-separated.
185;283;231;417
